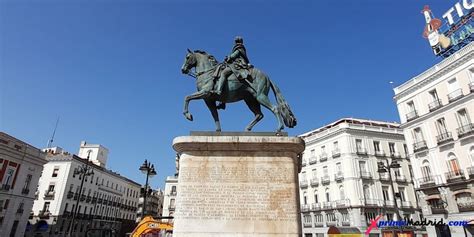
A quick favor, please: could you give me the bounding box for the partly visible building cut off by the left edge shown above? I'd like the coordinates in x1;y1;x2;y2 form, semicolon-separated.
0;132;46;237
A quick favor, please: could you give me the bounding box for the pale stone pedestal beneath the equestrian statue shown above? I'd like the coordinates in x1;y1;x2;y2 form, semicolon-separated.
173;132;304;237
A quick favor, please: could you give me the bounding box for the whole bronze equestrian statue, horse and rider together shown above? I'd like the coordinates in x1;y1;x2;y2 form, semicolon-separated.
181;37;296;132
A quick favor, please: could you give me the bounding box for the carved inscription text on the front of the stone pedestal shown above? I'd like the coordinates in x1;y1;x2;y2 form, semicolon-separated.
175;165;297;222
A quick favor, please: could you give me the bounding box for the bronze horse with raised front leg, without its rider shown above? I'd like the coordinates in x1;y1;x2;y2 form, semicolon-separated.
181;49;296;132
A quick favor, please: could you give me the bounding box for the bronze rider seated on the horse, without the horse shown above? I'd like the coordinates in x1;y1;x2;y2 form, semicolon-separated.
213;36;250;96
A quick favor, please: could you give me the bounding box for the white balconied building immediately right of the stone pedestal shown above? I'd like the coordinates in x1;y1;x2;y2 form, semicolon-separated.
299;118;423;237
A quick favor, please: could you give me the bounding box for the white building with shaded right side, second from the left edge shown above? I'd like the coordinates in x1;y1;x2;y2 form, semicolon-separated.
27;142;140;236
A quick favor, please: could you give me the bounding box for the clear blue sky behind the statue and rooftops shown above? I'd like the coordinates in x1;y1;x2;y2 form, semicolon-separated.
0;0;456;187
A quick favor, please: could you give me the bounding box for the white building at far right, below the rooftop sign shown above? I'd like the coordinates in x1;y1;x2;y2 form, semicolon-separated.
394;43;474;236
